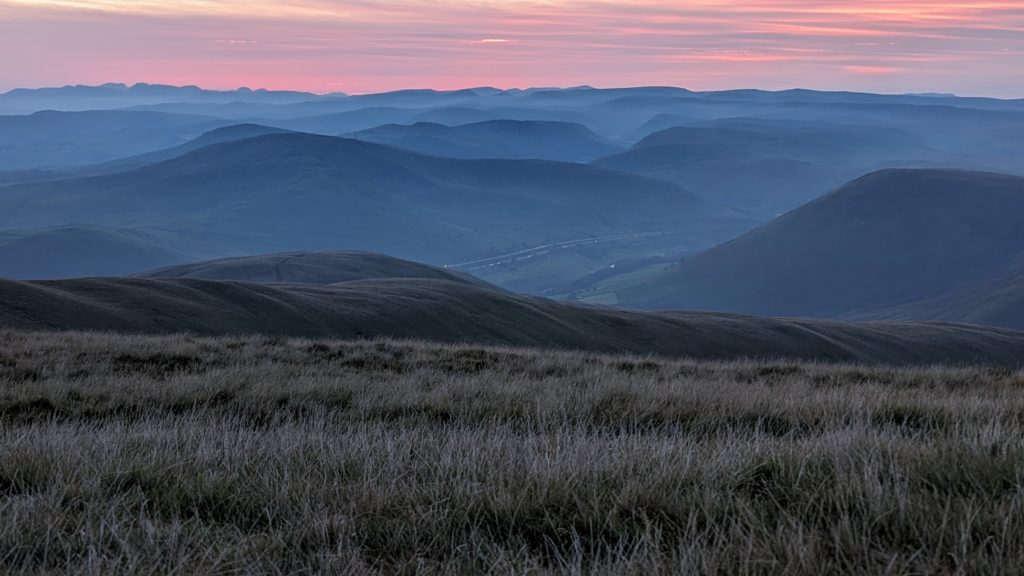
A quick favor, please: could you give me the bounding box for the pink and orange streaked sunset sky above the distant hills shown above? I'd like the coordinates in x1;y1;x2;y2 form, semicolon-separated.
0;0;1024;97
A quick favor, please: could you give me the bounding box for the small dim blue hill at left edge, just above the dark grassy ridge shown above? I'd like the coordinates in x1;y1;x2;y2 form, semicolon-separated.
0;225;188;280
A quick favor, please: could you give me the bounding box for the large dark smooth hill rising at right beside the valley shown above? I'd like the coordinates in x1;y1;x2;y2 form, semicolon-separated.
618;170;1024;328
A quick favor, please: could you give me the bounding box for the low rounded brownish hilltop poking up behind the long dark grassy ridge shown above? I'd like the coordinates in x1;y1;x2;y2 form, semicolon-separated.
137;251;486;286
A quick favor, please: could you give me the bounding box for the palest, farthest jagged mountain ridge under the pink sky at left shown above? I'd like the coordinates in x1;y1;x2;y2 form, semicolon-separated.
0;84;319;114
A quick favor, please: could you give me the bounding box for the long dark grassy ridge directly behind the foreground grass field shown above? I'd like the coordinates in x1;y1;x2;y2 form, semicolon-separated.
0;272;1024;365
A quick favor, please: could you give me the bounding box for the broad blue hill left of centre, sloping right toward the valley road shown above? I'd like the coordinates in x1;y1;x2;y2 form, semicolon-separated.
0;133;748;263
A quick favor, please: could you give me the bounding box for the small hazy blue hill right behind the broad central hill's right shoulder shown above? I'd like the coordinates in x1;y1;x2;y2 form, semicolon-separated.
357;120;621;162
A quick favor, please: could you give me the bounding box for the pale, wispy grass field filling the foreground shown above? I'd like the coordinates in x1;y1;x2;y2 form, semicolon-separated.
0;332;1024;574
